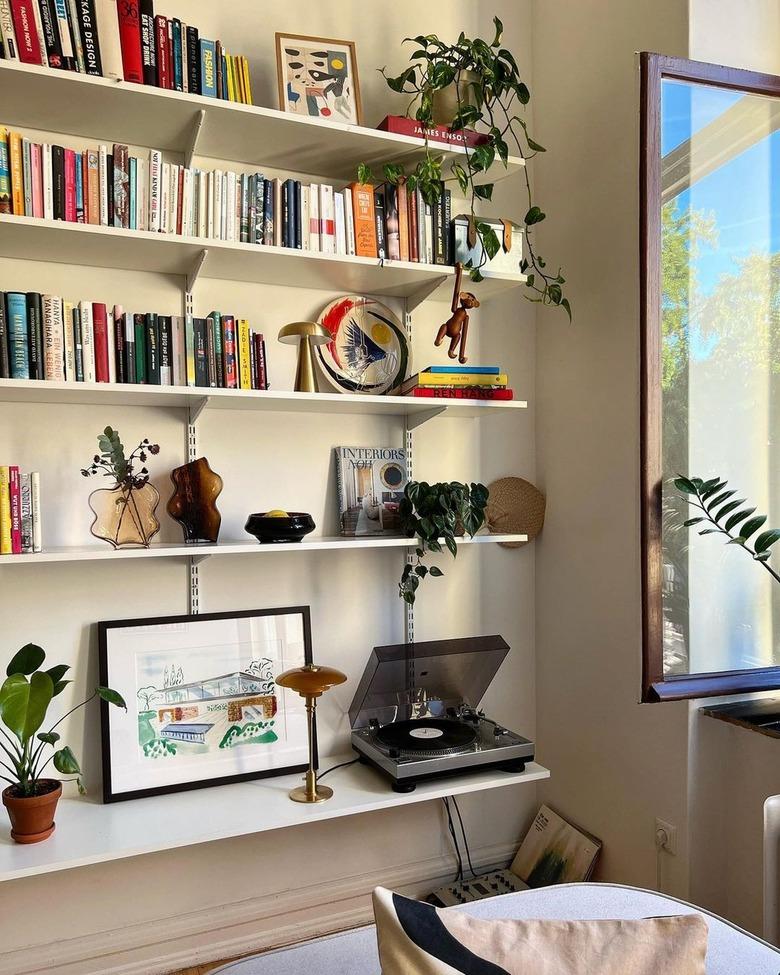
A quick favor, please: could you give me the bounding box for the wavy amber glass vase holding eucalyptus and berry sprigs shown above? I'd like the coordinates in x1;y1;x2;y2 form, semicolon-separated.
81;427;160;548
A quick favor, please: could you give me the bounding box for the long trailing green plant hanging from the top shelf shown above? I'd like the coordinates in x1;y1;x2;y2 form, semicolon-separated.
358;17;571;320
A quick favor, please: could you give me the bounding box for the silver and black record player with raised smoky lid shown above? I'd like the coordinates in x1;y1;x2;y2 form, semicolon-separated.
349;636;534;792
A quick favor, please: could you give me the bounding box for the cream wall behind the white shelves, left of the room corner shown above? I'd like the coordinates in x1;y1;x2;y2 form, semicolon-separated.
0;0;535;975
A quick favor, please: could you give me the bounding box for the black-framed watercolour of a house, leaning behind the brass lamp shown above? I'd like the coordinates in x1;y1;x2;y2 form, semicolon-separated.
98;606;312;802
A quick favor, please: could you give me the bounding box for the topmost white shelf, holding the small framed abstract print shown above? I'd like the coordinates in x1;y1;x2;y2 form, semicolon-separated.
0;61;523;180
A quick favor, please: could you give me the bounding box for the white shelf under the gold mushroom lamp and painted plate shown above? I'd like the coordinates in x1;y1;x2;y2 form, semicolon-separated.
0;379;528;422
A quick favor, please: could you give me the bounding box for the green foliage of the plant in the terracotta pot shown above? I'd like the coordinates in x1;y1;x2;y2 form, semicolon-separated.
0;643;127;798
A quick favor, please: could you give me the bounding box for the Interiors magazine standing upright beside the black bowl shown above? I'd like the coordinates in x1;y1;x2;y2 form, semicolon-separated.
335;447;407;536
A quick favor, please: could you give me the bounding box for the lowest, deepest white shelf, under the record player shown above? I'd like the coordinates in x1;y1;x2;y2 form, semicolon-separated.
0;755;550;881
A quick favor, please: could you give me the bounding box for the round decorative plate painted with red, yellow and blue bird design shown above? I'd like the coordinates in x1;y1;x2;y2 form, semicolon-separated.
316;295;409;394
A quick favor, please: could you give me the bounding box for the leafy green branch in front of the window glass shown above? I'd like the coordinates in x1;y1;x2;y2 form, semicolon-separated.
674;475;780;582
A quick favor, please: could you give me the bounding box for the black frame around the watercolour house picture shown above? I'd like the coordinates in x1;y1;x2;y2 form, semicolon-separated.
97;606;317;803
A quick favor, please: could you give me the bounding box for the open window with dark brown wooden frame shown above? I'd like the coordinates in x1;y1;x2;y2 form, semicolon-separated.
641;54;780;701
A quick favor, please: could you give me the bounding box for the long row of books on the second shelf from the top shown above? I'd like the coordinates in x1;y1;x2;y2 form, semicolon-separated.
0;132;454;264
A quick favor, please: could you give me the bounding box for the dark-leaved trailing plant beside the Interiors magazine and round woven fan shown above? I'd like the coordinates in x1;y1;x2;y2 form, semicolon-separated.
398;481;488;606
